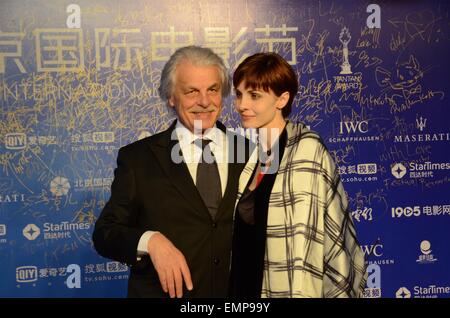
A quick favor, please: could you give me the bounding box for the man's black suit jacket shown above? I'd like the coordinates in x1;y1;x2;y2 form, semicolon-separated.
93;122;249;297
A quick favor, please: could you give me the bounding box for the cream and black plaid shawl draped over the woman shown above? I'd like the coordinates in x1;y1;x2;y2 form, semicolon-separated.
236;122;366;298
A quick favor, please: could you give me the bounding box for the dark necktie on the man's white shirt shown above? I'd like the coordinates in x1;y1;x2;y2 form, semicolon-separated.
195;139;222;220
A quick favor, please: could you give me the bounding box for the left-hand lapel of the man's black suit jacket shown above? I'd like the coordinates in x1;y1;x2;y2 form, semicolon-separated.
150;121;209;215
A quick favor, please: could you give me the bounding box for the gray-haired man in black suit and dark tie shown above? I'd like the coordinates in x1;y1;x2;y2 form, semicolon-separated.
93;46;251;297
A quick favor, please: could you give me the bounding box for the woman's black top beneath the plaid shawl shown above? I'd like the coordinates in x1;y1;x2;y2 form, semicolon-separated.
230;129;287;298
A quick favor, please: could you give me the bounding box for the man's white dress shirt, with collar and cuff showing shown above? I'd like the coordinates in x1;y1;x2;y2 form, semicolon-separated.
137;120;228;261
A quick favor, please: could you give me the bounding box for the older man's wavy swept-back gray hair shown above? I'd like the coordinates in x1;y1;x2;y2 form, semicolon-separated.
158;45;231;102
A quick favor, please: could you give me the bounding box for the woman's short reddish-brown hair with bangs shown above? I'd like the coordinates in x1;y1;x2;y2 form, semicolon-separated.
233;53;298;118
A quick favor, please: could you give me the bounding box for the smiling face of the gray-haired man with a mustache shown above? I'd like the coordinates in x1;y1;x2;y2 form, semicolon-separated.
169;60;222;132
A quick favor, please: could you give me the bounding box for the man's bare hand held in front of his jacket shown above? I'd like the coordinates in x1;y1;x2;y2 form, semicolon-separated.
147;232;193;298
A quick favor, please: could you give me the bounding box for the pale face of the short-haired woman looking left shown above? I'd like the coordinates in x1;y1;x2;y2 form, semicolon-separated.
234;81;289;128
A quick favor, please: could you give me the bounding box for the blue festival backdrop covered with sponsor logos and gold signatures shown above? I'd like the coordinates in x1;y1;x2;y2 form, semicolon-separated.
0;0;450;298
